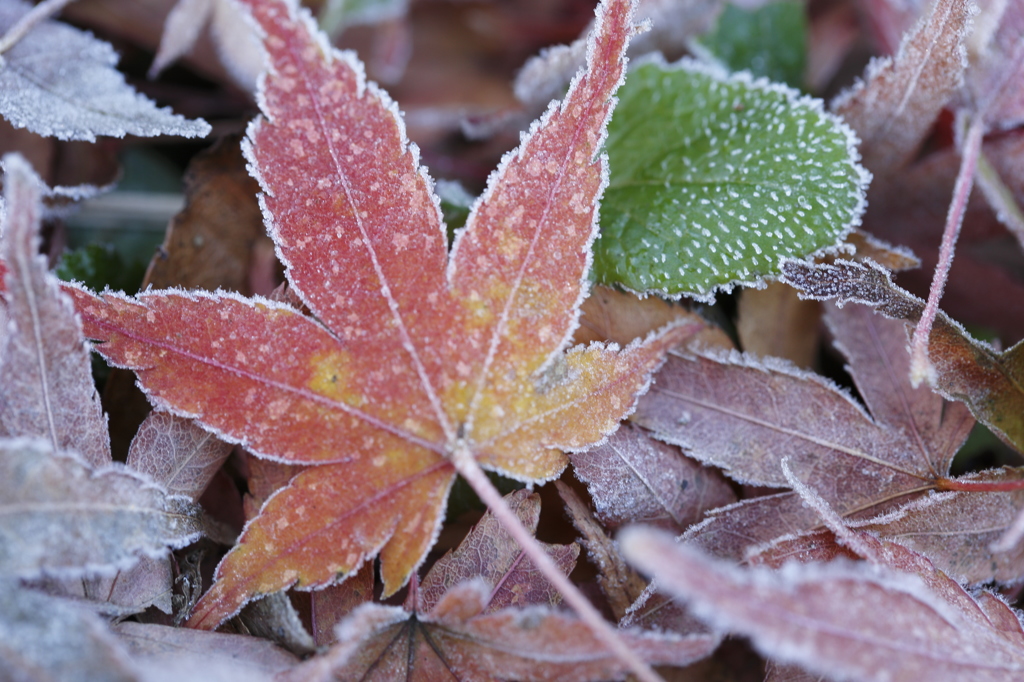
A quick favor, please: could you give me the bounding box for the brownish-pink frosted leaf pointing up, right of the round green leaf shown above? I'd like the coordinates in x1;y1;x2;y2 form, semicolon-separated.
831;0;975;175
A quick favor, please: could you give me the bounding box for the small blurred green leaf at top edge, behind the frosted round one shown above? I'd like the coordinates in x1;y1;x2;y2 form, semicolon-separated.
695;0;807;88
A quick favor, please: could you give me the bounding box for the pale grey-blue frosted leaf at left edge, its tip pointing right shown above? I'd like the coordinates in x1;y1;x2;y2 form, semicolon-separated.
0;438;202;578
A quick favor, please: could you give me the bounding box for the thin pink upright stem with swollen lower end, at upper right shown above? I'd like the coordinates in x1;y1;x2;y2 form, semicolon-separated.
910;113;985;388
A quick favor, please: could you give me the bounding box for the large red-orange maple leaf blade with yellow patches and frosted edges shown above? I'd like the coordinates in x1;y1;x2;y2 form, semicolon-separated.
66;0;685;628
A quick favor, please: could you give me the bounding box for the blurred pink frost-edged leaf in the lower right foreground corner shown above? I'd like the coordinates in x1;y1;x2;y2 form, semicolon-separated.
622;528;1024;682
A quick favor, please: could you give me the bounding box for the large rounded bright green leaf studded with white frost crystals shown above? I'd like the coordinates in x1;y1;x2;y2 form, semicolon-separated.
594;60;869;299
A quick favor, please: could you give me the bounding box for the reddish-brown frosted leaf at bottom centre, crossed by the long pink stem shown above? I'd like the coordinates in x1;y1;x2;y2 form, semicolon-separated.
296;582;718;682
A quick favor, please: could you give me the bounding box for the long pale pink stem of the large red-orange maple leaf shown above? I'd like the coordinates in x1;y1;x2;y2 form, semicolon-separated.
452;447;664;682
